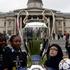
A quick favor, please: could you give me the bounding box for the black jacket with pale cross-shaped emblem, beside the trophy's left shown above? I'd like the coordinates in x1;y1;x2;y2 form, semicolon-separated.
4;47;27;70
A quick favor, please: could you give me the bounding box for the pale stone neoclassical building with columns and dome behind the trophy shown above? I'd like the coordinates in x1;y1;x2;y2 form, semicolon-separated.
0;0;70;35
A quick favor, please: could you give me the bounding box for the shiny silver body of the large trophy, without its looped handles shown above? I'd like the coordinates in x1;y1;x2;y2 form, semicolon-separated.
23;22;48;69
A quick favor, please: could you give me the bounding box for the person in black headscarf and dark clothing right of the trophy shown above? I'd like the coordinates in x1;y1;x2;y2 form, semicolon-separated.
44;44;63;70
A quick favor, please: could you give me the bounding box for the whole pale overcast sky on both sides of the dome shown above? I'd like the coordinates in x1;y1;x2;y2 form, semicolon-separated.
0;0;70;13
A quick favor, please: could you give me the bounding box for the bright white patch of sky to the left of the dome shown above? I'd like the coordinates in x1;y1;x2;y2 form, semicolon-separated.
0;0;27;11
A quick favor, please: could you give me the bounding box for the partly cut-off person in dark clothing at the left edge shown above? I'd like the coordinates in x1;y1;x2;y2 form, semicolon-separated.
0;33;7;70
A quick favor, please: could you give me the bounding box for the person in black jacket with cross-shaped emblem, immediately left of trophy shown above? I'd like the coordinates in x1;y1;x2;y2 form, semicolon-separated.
4;35;27;70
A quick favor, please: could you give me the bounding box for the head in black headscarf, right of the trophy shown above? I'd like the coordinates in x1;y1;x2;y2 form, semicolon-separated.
47;44;63;57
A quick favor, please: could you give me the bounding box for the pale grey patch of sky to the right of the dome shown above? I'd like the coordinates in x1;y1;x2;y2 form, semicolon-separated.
43;0;70;11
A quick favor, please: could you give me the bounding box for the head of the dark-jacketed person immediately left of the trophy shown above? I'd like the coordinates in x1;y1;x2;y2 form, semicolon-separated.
10;35;21;48
